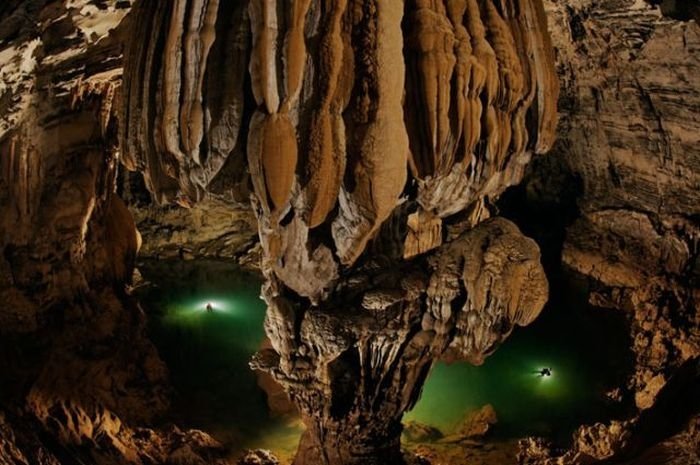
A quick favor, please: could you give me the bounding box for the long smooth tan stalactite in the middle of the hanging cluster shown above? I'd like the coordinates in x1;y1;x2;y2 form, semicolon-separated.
332;1;409;265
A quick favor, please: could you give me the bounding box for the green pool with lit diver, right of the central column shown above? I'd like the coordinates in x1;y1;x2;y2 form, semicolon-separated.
406;279;632;440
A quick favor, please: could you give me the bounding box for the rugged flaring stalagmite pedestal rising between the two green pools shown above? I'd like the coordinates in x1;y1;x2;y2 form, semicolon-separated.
253;218;547;464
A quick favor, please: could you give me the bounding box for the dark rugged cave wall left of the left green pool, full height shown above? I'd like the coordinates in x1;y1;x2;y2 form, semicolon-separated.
0;0;235;465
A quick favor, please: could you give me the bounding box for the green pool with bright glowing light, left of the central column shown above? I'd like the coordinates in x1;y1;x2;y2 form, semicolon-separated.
138;260;301;454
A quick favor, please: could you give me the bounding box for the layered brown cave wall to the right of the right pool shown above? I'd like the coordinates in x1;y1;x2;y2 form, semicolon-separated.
523;0;700;464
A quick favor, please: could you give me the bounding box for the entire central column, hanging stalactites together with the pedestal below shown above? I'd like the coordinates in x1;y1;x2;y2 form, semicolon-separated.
120;0;558;465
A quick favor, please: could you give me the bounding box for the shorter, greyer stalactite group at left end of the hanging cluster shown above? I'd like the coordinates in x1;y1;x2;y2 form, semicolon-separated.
120;0;250;206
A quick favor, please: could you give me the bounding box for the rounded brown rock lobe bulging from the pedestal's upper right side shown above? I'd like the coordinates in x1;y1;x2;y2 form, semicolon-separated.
423;218;548;364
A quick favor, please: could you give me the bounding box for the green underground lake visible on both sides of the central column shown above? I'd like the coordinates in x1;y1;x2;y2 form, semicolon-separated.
136;260;632;460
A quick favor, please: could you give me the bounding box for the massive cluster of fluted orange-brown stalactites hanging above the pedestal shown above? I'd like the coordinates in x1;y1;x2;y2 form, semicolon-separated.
123;0;558;302
